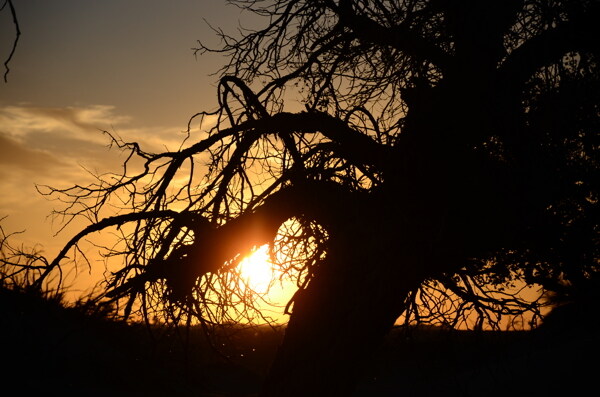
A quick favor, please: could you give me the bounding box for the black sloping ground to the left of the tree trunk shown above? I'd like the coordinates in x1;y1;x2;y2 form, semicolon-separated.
0;288;281;396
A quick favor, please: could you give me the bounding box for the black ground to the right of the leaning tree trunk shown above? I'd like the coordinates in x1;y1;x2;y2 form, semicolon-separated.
355;300;600;397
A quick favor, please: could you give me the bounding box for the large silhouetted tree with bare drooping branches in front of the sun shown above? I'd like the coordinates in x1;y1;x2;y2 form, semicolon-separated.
2;0;600;396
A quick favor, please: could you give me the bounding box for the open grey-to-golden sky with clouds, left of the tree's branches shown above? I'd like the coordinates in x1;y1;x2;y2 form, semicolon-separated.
0;0;254;256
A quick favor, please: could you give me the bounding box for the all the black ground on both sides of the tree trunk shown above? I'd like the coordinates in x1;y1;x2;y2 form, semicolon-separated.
0;289;600;397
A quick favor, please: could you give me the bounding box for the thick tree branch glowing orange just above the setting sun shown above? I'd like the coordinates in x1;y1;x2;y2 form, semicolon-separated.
107;182;360;298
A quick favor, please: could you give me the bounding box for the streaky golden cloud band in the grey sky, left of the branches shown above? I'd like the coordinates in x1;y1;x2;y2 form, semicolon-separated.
0;105;198;176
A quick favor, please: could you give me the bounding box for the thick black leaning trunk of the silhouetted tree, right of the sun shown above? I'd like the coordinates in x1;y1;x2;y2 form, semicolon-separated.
262;195;434;397
